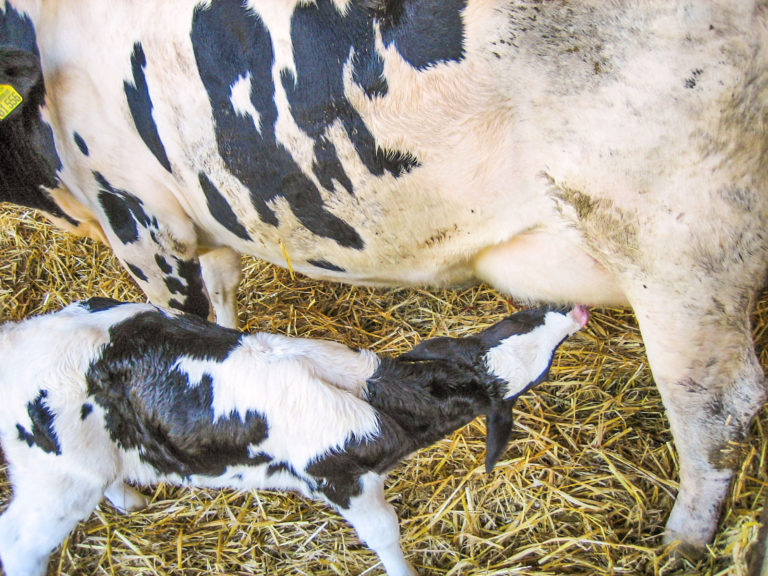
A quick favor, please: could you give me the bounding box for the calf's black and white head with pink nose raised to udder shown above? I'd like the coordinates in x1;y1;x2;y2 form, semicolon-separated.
401;306;589;472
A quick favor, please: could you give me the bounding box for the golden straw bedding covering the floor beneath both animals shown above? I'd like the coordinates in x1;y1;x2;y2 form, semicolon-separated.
0;207;768;576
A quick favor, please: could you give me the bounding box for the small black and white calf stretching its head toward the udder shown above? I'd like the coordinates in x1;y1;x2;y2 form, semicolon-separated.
0;299;587;576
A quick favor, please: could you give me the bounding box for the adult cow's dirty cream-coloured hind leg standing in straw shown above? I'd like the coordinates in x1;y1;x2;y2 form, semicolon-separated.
635;294;766;554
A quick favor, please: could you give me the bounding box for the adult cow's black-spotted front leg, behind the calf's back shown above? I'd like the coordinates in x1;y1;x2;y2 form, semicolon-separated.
96;174;211;318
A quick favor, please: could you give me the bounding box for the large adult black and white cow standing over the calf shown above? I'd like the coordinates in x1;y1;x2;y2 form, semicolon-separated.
0;0;768;550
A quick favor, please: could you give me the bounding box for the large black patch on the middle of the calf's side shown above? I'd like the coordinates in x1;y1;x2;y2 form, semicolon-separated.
86;312;269;477
